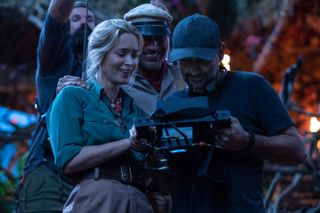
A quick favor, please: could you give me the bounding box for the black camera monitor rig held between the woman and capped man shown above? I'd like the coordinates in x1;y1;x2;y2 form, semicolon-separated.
134;97;230;171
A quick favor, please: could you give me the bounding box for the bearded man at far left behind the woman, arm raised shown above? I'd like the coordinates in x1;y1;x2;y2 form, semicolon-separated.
17;0;96;212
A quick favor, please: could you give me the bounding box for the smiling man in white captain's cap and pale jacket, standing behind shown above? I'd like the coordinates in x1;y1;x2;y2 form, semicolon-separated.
124;4;186;212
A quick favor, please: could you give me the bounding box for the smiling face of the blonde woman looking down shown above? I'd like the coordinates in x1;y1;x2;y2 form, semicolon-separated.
97;33;139;86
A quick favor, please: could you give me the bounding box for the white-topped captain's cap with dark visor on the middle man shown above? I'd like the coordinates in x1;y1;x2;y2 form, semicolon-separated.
123;4;172;36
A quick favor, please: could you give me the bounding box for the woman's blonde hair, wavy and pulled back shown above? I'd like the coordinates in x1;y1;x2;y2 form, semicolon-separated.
86;19;143;80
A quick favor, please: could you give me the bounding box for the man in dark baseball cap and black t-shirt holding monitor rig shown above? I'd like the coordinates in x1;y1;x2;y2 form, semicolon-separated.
170;14;306;213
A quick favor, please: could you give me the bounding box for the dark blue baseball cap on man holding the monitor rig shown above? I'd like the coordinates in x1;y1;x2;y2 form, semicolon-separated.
170;13;221;62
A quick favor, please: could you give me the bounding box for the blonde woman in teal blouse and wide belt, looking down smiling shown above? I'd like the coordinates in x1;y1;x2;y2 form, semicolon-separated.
47;19;152;213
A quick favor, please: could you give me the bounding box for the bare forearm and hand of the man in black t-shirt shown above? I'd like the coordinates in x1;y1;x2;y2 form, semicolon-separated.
221;117;307;164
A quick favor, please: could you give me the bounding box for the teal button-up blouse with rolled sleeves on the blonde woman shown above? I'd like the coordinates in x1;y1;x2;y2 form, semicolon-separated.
47;81;138;171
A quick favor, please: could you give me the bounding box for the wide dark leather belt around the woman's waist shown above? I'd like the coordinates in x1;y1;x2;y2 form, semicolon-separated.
76;164;146;192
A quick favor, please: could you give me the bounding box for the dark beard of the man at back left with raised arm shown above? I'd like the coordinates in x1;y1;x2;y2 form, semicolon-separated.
71;25;92;53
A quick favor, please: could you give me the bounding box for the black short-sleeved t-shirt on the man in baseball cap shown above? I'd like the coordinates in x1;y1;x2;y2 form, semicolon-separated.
172;72;295;213
